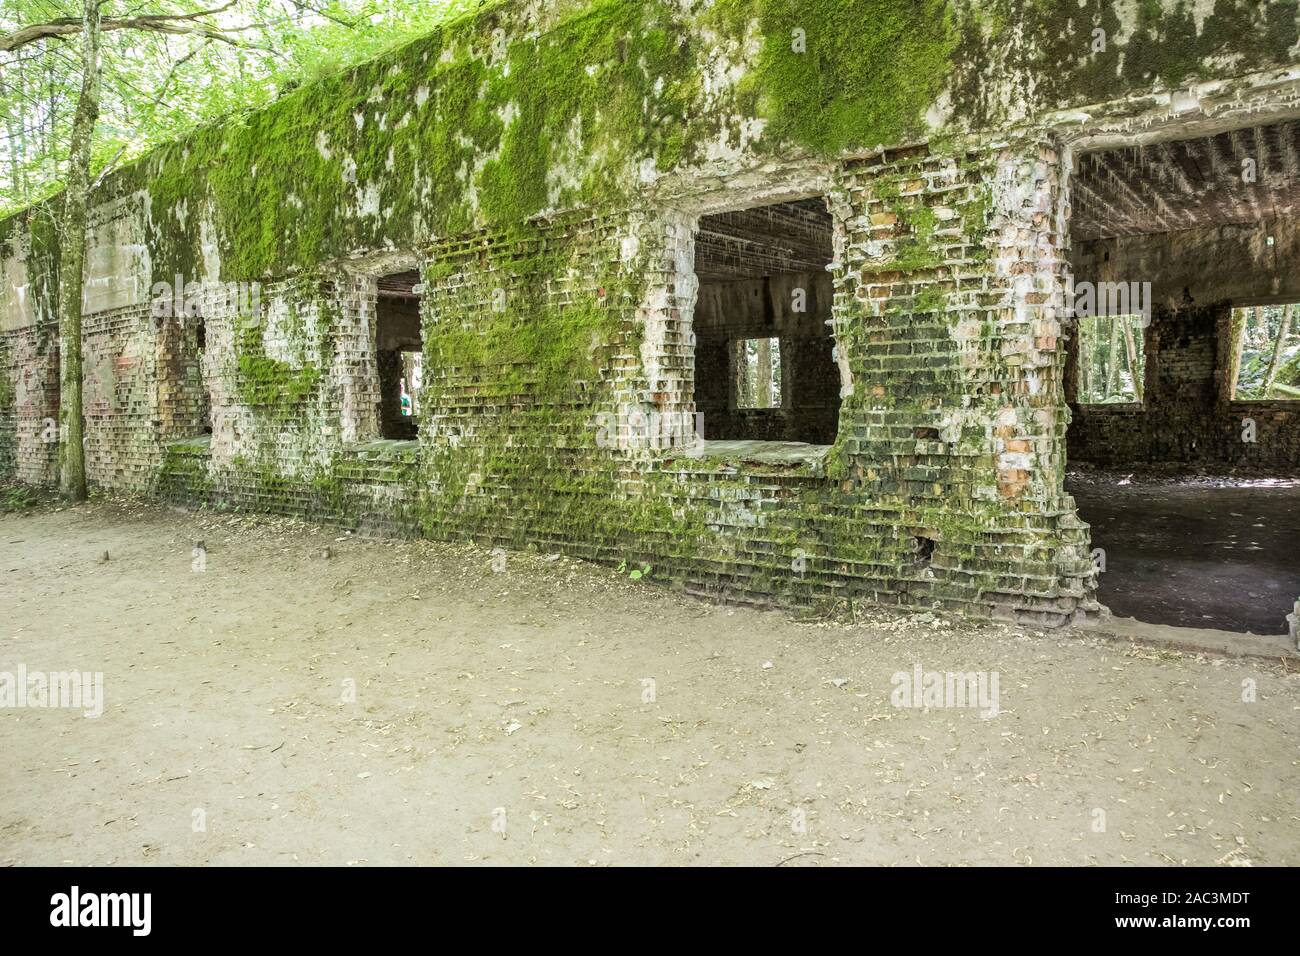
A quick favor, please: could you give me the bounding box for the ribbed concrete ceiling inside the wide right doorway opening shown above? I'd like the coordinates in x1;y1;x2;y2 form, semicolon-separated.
1070;121;1300;241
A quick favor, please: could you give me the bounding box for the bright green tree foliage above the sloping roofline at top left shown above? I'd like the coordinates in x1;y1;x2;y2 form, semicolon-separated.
0;0;501;212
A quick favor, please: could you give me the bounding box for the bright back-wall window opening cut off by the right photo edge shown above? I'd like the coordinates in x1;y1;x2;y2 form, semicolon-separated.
1232;302;1300;402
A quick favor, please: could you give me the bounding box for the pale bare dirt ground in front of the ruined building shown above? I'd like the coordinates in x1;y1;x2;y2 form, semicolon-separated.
0;502;1300;866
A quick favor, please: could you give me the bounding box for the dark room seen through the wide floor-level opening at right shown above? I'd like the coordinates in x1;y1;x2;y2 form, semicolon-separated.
1065;122;1300;635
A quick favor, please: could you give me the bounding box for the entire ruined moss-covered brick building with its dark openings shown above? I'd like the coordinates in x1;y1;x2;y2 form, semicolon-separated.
0;0;1300;626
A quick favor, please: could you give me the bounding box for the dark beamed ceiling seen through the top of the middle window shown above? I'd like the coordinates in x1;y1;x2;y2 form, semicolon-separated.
696;198;833;282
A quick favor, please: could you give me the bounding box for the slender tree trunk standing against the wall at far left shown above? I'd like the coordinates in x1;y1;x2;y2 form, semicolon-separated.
59;0;100;501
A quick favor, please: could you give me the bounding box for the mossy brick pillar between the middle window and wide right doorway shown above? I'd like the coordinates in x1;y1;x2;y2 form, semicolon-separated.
833;138;1096;624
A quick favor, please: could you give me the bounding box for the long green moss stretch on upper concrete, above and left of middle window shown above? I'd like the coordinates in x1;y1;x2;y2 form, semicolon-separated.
106;0;701;281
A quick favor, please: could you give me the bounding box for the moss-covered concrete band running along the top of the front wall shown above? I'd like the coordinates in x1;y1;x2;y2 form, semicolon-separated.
10;0;1297;287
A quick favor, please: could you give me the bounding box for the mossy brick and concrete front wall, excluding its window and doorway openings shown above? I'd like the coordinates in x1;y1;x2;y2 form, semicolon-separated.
0;0;1296;623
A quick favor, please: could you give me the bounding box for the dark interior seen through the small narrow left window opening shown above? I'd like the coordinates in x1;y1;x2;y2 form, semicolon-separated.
374;269;424;441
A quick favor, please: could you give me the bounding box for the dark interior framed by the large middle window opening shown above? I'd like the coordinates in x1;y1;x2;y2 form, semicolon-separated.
694;198;840;445
